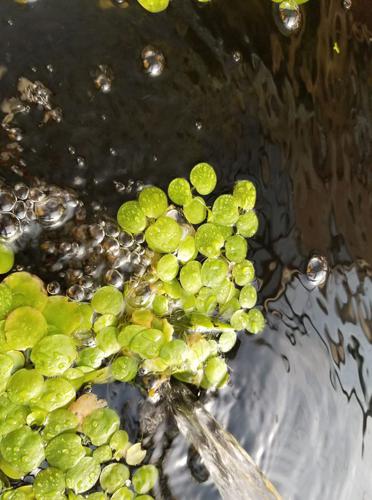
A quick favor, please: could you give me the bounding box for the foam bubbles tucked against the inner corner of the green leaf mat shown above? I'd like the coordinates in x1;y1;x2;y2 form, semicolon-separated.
41;214;153;301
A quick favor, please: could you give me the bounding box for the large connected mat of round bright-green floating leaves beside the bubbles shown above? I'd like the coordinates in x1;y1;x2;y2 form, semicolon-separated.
0;163;264;500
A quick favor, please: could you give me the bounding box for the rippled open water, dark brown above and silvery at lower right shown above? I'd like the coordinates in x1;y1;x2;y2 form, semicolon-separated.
0;0;372;500
